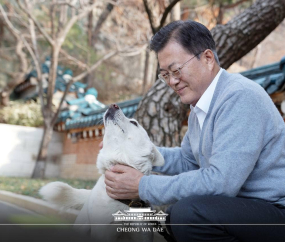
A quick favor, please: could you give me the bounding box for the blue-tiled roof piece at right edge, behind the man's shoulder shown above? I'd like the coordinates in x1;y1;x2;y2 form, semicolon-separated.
240;56;285;95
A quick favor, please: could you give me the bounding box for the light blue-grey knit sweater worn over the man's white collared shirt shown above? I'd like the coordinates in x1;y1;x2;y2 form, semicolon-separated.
139;71;285;206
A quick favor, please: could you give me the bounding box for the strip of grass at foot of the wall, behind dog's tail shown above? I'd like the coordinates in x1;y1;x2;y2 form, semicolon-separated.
0;177;96;198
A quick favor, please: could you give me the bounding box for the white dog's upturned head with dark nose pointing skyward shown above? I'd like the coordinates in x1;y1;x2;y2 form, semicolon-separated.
97;104;164;175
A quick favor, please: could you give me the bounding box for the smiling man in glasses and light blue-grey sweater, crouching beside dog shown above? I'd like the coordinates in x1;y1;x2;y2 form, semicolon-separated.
105;20;285;242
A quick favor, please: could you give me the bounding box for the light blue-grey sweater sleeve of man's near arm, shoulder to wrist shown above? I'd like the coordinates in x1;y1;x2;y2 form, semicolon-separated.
139;90;270;205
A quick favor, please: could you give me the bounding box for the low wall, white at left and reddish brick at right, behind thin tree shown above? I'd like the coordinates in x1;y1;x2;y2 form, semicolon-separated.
0;124;102;180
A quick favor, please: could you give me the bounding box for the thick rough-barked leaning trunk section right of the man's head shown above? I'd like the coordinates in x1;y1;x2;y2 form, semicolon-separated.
211;0;285;69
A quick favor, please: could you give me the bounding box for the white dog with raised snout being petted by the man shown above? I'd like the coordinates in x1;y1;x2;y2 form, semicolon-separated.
40;104;164;242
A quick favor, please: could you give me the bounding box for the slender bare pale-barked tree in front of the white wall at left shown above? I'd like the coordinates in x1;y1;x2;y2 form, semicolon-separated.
0;0;117;178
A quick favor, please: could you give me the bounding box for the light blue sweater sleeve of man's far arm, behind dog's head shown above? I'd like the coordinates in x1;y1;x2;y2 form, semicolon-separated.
152;131;199;175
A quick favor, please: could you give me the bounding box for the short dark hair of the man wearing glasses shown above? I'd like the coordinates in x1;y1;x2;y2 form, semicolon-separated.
150;20;220;64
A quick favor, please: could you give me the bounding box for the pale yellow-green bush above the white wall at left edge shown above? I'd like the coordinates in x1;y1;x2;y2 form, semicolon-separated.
0;100;43;127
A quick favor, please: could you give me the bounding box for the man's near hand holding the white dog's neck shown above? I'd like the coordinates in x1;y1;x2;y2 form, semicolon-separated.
105;165;144;199
